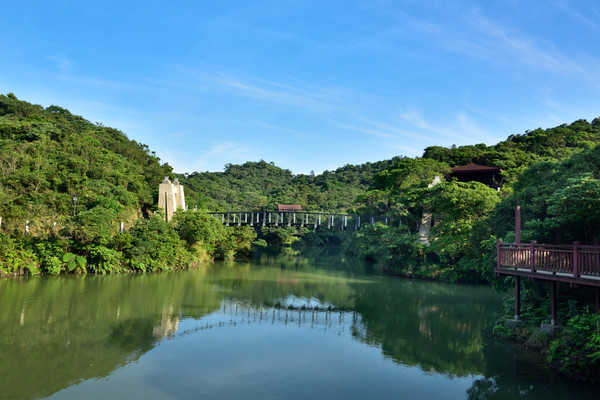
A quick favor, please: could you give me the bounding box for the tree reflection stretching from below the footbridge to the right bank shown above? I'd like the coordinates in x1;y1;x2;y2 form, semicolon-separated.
212;255;500;376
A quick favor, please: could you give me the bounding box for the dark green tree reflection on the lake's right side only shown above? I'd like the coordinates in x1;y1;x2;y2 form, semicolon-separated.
355;279;498;376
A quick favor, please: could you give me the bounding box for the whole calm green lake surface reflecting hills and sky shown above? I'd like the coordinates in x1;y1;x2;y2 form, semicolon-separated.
0;250;600;400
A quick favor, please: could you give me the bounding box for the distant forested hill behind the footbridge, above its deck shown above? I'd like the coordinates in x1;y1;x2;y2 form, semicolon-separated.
179;157;401;212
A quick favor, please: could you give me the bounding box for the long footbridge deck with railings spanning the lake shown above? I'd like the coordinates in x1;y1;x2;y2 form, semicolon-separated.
208;211;400;230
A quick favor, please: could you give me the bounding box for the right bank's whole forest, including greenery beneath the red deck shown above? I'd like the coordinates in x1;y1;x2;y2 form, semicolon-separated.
345;118;600;382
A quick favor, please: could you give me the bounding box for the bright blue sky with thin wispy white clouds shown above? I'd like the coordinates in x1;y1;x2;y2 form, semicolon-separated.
0;0;600;173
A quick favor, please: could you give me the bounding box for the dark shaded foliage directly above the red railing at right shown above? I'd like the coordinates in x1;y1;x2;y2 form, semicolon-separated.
490;145;600;243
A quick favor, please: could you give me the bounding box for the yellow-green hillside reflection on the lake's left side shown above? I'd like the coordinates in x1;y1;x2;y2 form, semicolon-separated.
0;271;220;399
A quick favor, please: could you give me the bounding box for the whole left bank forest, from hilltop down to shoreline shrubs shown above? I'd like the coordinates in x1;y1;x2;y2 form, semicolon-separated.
0;94;255;275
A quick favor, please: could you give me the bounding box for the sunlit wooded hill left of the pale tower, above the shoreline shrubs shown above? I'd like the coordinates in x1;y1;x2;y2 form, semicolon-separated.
0;94;172;231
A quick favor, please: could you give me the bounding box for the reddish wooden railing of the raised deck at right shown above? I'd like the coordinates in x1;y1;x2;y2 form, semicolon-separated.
497;240;600;279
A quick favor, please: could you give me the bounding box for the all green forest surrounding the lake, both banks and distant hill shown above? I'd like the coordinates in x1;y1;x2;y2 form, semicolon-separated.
0;94;600;380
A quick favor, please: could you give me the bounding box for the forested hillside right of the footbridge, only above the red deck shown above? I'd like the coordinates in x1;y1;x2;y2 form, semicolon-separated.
348;118;600;281
